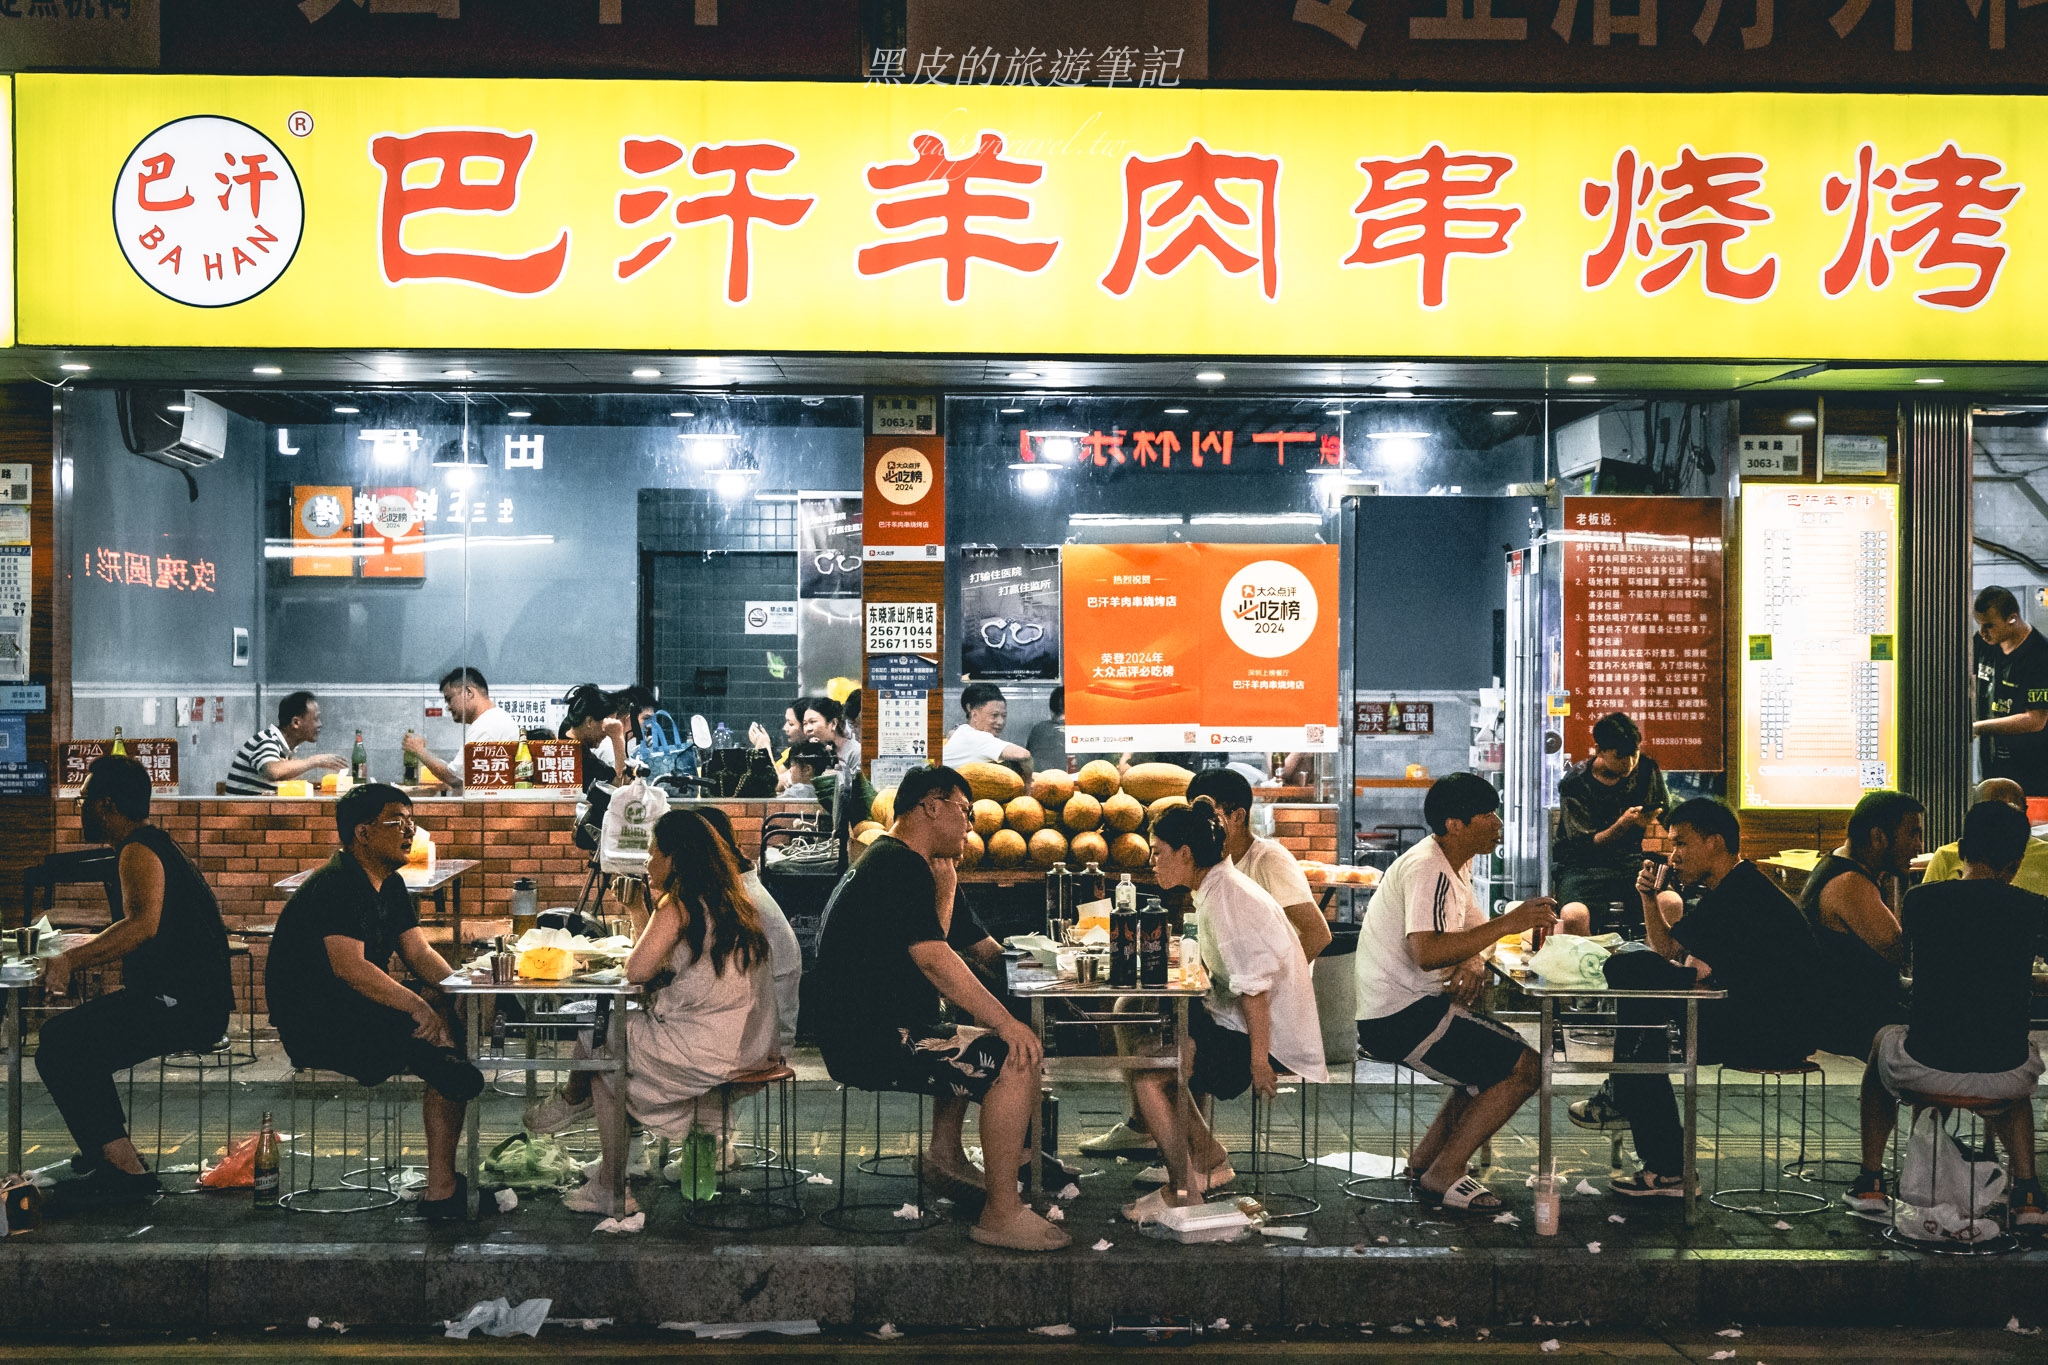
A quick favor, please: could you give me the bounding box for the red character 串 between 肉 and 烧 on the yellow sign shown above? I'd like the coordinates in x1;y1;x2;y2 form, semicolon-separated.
1343;143;1522;309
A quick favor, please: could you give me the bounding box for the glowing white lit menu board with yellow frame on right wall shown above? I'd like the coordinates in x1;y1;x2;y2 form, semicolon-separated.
1741;483;1898;810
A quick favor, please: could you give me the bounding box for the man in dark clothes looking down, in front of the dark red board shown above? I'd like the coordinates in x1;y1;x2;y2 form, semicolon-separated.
1550;710;1671;937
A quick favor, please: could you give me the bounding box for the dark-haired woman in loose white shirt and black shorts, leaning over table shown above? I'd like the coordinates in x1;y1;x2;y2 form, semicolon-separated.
1124;796;1329;1222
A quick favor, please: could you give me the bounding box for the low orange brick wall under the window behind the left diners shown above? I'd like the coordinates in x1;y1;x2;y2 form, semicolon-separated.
57;798;817;1013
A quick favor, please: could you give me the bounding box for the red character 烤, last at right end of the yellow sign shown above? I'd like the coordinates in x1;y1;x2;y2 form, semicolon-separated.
1821;143;2021;311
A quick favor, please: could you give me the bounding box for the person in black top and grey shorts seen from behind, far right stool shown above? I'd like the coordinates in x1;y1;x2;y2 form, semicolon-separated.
1843;800;2048;1226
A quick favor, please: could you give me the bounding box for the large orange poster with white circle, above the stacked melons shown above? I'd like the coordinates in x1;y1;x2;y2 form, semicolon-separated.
1061;544;1339;751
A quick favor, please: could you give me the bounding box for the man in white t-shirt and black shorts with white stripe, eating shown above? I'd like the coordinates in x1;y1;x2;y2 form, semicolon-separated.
1356;774;1556;1212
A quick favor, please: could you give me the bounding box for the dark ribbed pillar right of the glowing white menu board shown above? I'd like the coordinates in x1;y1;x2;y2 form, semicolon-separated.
1898;401;1974;847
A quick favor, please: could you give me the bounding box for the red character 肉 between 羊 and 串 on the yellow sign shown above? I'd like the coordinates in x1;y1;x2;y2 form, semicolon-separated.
1102;141;1280;299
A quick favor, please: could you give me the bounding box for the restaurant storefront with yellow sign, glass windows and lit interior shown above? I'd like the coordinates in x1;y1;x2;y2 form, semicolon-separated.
6;76;2015;1015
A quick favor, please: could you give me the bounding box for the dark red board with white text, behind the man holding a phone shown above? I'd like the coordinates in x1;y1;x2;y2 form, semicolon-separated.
1565;497;1726;772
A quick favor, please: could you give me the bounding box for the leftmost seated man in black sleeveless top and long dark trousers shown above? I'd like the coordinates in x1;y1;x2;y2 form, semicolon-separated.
35;753;236;1209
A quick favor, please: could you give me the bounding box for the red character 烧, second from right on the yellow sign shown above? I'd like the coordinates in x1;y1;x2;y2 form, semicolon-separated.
1579;147;1778;303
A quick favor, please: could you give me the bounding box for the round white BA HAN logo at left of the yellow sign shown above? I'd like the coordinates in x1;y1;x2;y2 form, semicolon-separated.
115;115;305;309
